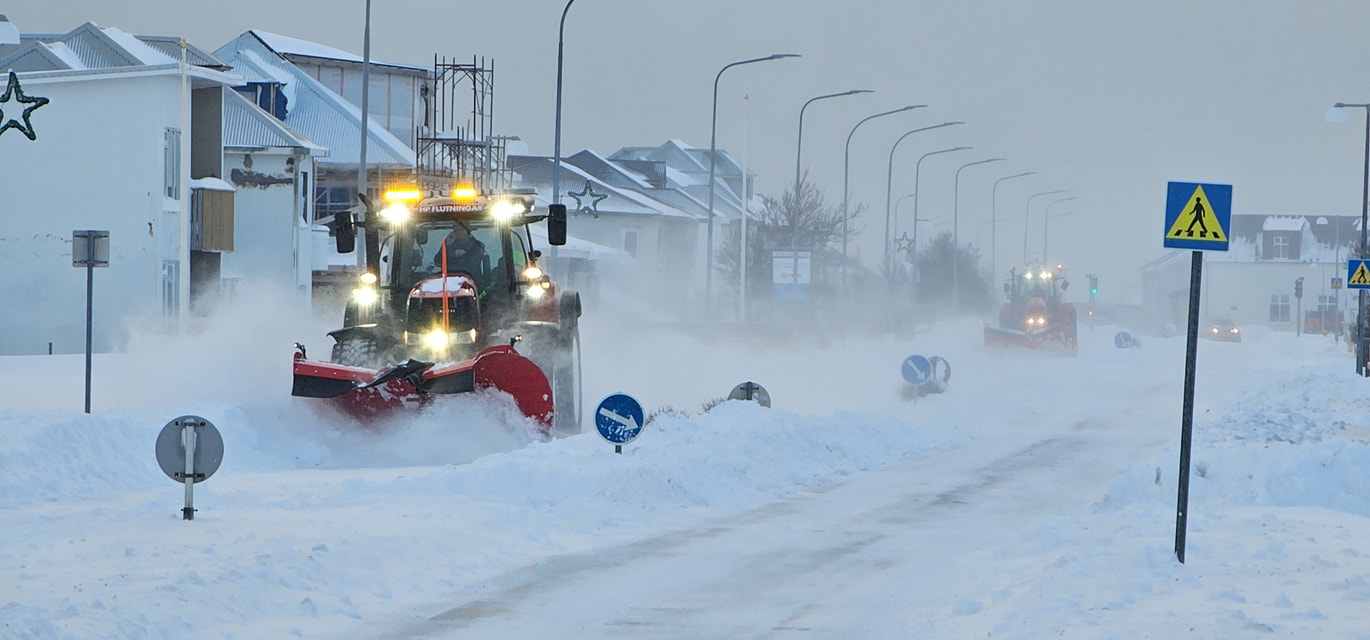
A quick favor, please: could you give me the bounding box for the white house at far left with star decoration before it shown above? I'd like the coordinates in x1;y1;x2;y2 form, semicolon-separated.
0;22;240;354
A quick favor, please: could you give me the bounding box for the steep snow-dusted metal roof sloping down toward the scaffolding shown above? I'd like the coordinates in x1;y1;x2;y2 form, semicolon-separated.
214;32;415;167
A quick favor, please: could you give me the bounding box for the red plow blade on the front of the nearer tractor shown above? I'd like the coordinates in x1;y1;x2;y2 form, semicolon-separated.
290;345;552;432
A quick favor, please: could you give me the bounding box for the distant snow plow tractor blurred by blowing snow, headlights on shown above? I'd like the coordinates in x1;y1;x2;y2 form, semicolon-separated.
985;264;1077;355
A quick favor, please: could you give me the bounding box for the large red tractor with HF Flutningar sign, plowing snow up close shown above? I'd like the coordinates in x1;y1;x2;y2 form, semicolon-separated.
292;188;581;434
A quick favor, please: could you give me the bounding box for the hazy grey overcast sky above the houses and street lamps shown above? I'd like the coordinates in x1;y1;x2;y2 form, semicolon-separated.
4;0;1370;293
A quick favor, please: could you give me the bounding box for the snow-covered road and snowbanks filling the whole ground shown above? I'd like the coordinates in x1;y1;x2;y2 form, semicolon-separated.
0;319;1370;639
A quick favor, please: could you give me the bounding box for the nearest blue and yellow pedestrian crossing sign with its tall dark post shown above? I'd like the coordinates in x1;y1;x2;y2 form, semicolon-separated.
1163;182;1232;565
